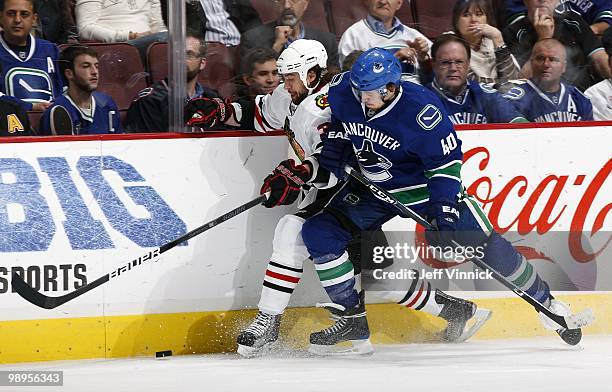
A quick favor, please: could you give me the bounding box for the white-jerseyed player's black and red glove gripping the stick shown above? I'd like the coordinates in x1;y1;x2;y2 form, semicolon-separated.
260;159;310;208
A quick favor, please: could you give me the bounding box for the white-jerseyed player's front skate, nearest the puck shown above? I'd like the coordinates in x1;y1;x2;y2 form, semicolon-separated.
236;311;282;357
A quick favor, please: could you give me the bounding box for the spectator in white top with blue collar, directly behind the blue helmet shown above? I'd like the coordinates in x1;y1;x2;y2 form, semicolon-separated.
338;0;431;83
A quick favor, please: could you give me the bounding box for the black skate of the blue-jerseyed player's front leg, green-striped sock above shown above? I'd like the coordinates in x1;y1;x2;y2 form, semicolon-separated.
308;291;374;355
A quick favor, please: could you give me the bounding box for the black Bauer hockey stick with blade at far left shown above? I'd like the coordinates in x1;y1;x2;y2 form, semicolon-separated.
11;193;269;309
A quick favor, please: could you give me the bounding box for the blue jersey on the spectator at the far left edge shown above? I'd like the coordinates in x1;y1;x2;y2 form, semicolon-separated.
0;34;63;110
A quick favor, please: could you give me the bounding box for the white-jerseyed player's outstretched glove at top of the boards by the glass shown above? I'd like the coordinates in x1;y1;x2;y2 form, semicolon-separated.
185;98;234;128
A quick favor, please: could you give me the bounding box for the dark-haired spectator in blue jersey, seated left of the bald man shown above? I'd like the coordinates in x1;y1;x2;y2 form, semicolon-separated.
428;34;527;124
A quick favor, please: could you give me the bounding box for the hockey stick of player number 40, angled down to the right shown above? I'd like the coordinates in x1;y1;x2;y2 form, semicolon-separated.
345;165;595;329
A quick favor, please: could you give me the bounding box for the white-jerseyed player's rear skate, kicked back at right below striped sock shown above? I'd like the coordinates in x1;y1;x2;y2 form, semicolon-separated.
435;289;492;343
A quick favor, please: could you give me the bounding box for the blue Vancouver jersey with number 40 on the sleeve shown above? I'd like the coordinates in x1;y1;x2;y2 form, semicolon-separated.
324;72;463;209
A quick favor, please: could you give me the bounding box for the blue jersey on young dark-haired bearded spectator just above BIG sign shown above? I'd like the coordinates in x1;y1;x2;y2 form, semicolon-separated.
40;91;123;135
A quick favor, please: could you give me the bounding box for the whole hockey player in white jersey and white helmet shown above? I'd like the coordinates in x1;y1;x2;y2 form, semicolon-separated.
186;40;490;356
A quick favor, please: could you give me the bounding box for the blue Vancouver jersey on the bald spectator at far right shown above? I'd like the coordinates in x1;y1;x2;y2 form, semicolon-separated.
504;80;593;122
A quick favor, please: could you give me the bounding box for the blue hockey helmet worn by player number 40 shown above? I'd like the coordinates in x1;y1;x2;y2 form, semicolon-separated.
350;48;402;91
